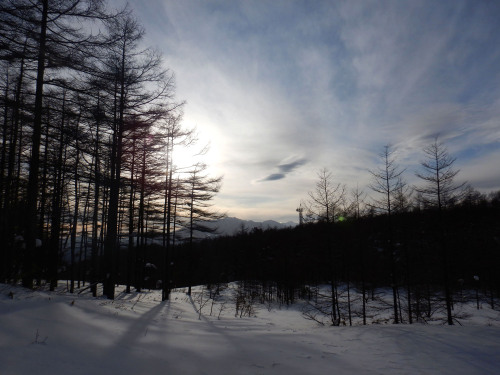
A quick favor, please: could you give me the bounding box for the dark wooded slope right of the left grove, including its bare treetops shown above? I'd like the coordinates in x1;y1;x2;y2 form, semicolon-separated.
170;139;500;325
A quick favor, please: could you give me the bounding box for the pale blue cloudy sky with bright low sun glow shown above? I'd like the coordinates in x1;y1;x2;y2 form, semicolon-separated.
114;0;500;222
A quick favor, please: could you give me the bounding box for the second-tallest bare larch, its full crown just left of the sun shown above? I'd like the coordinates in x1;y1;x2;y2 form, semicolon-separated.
98;13;182;299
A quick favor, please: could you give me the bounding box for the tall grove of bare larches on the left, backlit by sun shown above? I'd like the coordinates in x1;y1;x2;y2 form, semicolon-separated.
0;0;221;299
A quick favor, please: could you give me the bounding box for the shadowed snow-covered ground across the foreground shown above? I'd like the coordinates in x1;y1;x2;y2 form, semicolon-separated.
0;284;500;375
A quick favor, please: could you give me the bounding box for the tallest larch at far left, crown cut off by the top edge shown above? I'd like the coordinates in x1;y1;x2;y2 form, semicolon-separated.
0;0;111;287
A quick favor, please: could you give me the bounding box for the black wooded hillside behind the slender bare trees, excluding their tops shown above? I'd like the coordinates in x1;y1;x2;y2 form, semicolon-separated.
174;191;500;325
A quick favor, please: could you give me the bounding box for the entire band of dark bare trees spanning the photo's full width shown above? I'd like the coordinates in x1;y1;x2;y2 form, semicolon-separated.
0;0;500;325
